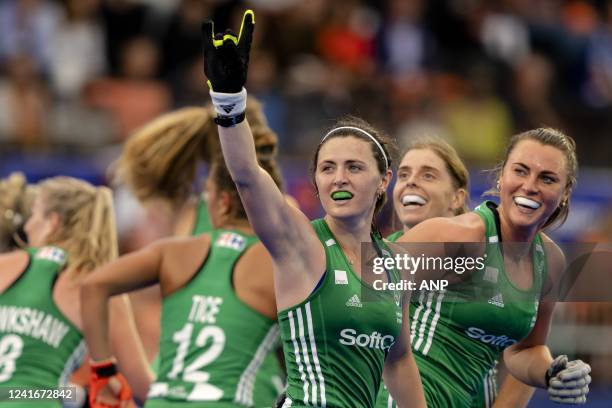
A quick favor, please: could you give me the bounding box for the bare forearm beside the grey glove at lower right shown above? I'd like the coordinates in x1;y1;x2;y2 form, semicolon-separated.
504;345;553;388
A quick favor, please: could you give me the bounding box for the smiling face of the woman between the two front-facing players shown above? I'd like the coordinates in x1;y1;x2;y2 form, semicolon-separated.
393;148;466;228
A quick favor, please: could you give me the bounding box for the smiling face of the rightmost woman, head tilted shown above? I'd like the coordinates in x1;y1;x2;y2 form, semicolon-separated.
499;139;568;230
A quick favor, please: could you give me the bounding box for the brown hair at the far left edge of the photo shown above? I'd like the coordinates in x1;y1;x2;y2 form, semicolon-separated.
0;172;35;252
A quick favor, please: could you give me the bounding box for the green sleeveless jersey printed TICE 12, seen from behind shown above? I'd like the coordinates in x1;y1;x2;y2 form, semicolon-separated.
146;229;279;407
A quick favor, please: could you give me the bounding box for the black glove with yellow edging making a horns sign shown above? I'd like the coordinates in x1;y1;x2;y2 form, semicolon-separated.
202;10;255;94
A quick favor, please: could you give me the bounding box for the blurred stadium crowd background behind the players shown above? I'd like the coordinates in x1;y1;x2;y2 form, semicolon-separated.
0;0;612;407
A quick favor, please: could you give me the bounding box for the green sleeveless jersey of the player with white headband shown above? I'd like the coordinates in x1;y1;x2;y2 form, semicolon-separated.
278;219;402;408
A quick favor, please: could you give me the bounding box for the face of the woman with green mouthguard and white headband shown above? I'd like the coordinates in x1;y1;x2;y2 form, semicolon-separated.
315;136;391;219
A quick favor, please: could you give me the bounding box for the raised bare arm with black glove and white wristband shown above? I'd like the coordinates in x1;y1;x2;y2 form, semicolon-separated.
202;10;319;261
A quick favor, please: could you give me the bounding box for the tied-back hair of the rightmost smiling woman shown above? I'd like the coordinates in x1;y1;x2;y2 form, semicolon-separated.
484;128;578;229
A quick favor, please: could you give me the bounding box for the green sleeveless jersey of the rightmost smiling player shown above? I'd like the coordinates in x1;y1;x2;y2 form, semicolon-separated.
376;201;546;408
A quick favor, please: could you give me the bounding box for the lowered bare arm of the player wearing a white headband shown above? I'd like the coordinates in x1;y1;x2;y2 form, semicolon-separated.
383;301;426;408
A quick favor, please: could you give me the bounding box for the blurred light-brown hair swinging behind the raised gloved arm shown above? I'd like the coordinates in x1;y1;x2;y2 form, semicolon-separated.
114;97;277;208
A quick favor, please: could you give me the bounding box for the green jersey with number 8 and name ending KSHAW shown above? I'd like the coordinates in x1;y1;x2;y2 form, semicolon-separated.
0;246;85;407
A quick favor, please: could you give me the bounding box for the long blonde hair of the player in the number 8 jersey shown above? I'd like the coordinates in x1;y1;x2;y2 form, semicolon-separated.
39;177;118;274
